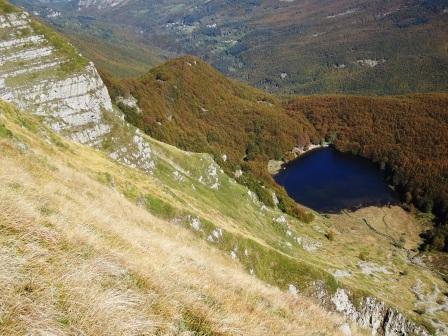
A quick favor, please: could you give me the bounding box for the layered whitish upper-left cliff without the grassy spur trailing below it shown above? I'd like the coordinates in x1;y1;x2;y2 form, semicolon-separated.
0;12;112;145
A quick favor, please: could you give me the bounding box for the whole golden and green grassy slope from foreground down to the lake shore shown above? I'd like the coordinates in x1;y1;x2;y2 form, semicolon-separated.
0;92;446;335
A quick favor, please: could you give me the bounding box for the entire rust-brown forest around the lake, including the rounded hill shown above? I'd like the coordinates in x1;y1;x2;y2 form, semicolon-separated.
103;57;448;249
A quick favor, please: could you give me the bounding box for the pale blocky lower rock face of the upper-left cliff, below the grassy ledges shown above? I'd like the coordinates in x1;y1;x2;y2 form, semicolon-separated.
0;64;112;144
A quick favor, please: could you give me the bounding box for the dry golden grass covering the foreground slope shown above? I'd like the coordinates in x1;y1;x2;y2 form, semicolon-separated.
0;114;364;335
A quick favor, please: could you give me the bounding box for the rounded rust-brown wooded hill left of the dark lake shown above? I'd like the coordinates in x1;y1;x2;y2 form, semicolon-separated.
103;57;318;220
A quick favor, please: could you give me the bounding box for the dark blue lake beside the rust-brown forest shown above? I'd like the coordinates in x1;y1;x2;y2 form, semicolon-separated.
274;148;398;213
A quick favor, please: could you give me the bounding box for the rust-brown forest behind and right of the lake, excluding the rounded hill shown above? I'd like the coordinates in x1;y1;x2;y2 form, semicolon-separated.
287;94;448;250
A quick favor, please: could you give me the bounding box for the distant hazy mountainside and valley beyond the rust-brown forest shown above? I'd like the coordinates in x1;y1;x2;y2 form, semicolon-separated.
12;0;448;94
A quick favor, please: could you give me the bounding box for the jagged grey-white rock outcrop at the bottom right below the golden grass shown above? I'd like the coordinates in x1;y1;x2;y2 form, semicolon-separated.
331;288;429;336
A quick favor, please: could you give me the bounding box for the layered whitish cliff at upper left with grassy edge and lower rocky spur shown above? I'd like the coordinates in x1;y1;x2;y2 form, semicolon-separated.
0;6;155;173
